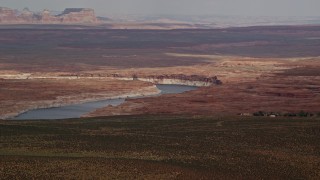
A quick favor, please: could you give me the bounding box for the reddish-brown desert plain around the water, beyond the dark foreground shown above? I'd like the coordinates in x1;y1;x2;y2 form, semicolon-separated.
0;26;320;117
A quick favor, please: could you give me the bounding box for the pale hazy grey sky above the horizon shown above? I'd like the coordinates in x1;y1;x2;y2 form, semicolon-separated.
0;0;320;17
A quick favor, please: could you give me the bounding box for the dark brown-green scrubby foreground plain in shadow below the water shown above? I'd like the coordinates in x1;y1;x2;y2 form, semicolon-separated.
0;116;320;179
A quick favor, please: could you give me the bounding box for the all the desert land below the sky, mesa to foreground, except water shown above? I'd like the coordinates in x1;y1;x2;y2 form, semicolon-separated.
0;3;320;179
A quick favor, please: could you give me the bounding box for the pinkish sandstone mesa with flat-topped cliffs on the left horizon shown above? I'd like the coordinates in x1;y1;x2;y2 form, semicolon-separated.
0;7;99;24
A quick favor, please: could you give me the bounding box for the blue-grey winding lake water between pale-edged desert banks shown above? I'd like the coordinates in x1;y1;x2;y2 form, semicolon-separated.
12;85;198;120
